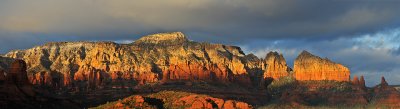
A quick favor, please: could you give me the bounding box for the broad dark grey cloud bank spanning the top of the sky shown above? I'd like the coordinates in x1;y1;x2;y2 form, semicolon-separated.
0;0;400;45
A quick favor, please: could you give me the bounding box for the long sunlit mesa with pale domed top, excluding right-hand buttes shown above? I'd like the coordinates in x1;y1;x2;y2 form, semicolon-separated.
5;32;259;86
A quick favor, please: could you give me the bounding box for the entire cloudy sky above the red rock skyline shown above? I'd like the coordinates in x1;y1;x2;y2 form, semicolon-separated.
0;0;400;86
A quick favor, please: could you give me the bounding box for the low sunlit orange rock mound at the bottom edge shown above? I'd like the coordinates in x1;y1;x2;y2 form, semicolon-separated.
98;91;253;109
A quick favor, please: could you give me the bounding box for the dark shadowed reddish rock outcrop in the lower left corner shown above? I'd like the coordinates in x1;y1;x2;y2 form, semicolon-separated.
0;59;79;109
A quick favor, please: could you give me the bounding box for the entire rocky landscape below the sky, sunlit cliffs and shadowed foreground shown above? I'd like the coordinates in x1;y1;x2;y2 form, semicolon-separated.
0;32;400;108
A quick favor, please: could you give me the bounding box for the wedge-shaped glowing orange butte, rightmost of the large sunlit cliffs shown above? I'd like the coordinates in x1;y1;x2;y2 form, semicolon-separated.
294;51;350;81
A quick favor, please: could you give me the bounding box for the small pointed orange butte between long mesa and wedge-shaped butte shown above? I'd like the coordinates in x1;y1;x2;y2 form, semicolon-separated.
264;52;291;80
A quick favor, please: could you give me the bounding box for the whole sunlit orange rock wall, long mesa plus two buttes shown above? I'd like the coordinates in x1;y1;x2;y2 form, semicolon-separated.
0;32;356;89
